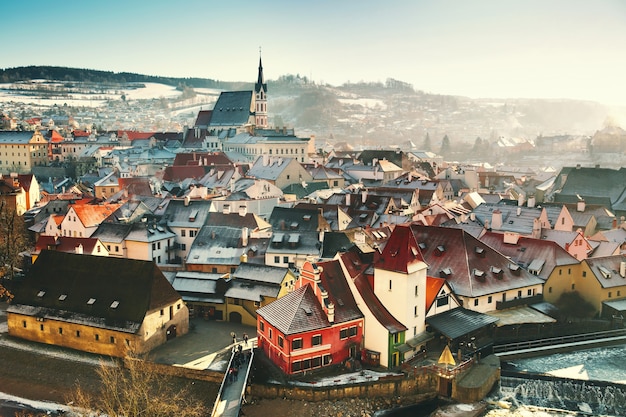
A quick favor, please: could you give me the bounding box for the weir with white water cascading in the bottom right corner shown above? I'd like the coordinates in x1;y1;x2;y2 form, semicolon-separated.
499;369;626;416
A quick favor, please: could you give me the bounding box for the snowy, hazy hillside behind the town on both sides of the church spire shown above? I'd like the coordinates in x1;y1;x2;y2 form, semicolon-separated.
0;66;610;159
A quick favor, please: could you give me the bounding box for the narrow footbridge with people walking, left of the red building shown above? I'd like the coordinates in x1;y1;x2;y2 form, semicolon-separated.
211;339;256;417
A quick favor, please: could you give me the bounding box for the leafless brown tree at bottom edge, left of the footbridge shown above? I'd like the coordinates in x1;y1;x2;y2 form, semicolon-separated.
68;355;208;417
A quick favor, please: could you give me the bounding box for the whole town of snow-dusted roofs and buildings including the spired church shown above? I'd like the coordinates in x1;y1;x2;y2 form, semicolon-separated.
0;57;626;374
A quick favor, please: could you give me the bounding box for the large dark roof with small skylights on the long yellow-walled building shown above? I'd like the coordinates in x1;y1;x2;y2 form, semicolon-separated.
8;250;180;333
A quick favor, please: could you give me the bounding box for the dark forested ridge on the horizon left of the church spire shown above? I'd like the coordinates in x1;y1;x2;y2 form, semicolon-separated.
0;66;244;89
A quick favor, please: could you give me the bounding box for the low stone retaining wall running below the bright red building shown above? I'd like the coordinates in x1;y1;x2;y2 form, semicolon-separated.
248;373;438;402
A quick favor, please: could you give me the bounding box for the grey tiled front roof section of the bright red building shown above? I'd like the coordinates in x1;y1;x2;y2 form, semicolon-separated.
257;285;331;335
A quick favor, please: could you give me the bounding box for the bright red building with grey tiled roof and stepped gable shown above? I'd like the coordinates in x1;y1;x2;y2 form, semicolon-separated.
257;261;363;374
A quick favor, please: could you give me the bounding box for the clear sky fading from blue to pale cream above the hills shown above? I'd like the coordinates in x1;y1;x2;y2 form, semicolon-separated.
0;0;626;105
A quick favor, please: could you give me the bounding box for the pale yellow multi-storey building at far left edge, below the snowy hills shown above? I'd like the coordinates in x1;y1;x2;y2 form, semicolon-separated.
0;130;48;174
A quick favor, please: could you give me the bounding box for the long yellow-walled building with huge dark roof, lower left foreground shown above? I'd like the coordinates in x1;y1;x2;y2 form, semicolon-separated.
7;250;189;357
